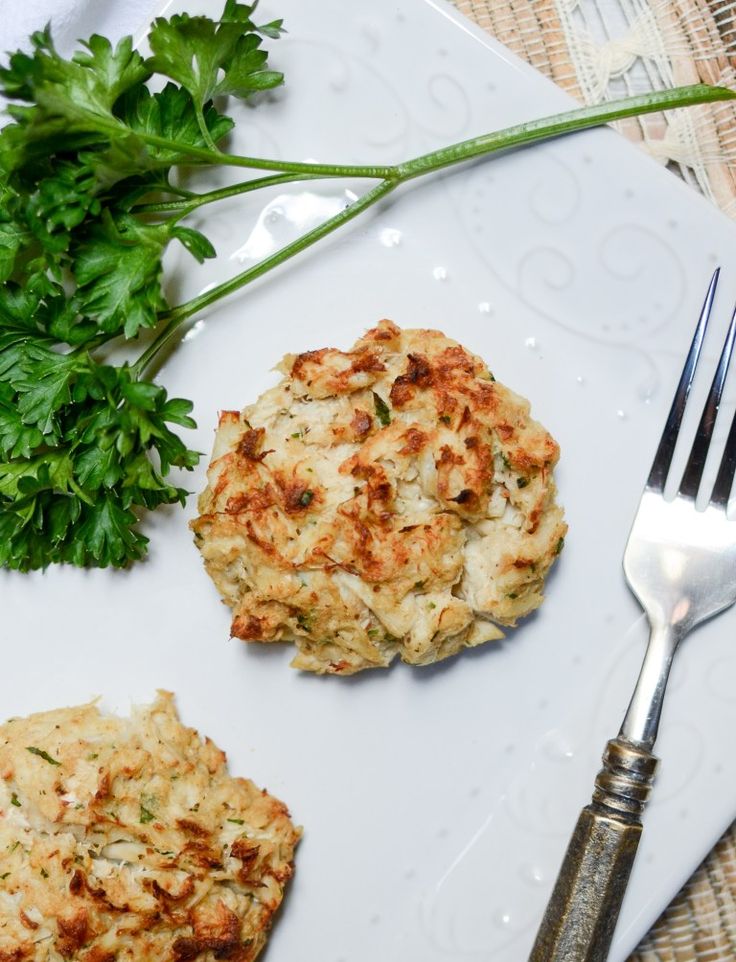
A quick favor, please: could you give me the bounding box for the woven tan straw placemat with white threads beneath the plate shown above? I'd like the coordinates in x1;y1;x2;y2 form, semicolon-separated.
455;0;736;962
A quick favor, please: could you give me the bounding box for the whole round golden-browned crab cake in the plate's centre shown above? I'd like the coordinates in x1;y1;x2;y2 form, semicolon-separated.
192;321;566;674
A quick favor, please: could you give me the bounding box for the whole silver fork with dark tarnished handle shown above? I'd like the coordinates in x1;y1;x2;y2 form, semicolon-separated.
529;269;736;962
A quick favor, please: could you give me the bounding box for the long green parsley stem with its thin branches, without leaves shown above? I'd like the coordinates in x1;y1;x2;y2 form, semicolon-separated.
133;84;736;377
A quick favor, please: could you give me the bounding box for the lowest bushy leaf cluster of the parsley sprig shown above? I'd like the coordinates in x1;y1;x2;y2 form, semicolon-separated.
0;360;198;570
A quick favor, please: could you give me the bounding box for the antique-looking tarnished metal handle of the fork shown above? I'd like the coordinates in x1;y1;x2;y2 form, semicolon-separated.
529;736;657;962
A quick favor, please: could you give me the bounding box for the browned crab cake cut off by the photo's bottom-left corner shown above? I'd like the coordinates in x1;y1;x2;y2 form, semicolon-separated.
0;693;299;962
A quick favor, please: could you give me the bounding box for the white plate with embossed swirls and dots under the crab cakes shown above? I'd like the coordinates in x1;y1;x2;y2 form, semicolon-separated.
0;0;736;962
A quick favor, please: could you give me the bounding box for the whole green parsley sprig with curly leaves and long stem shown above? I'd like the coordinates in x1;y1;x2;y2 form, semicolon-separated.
0;0;734;571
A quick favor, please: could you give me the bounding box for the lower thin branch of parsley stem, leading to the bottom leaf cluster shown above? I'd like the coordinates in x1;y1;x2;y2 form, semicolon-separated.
131;180;398;378
